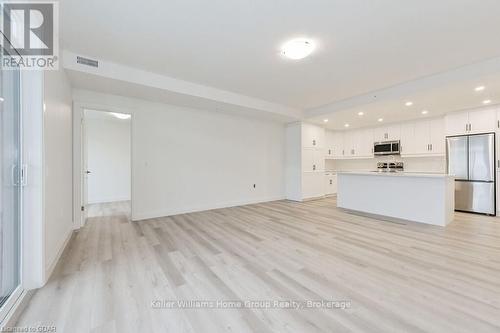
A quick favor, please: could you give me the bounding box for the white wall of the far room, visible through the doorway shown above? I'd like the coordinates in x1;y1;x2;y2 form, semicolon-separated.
85;110;131;203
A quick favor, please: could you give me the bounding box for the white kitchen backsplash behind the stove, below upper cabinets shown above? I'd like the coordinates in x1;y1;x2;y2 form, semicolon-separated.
325;156;446;173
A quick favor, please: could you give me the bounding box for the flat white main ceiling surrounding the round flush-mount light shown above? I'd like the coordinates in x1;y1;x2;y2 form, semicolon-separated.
60;0;500;109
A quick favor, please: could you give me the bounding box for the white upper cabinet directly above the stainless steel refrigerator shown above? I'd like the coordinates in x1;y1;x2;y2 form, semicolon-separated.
445;109;497;136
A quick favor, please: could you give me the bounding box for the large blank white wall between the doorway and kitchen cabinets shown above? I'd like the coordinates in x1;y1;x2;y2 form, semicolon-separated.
73;90;285;220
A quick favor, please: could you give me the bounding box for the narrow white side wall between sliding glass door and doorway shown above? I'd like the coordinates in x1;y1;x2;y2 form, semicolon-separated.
43;70;73;278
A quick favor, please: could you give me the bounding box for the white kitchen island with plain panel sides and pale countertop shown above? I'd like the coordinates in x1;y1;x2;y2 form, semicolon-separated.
337;171;455;226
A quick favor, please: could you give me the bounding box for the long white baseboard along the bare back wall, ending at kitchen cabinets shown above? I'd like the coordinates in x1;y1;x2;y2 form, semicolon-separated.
132;195;285;221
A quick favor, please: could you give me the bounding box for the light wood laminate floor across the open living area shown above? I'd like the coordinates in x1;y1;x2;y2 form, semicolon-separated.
13;198;500;333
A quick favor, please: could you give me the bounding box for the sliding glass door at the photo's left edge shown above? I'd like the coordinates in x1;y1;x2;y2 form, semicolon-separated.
0;42;22;321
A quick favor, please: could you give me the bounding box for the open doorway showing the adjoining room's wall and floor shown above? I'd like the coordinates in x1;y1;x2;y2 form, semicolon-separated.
82;109;132;219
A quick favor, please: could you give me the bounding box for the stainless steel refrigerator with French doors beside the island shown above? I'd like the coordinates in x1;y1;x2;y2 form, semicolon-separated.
446;133;496;215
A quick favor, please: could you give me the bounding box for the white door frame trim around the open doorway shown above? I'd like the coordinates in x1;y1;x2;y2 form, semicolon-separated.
73;101;135;230
